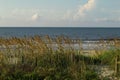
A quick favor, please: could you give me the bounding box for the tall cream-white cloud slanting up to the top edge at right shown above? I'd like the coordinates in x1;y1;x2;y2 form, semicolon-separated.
74;0;95;19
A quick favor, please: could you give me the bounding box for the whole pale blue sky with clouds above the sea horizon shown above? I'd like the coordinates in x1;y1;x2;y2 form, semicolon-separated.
0;0;120;27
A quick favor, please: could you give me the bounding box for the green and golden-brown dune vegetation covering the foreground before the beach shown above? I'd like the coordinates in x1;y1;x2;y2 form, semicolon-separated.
0;35;120;80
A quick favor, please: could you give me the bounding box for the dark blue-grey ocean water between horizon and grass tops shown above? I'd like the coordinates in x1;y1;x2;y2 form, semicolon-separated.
0;27;120;39
